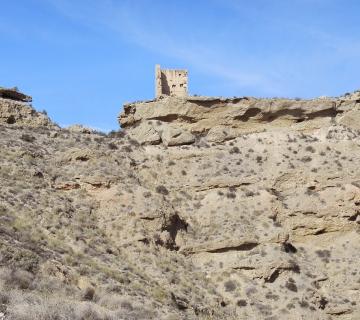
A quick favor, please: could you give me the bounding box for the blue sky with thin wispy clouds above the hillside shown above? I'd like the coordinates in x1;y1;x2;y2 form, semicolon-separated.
0;0;360;131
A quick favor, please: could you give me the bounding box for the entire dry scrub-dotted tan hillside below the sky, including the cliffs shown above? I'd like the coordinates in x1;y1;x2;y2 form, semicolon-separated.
0;92;360;320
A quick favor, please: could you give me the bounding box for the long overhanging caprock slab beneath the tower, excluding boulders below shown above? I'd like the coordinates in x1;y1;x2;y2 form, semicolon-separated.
119;97;338;133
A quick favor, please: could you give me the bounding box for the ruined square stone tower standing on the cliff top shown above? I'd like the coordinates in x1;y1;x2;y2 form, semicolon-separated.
155;64;188;98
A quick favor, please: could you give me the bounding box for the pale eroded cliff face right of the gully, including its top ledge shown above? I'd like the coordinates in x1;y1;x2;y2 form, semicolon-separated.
119;93;360;319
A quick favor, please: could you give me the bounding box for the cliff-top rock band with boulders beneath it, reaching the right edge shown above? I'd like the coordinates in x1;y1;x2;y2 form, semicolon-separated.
119;94;360;144
